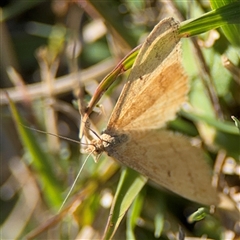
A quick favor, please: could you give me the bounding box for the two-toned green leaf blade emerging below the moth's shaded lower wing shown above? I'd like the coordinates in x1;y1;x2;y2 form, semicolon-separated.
103;168;147;239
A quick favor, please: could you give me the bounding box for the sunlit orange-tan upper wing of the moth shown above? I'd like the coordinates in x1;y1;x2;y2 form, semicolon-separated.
108;18;189;130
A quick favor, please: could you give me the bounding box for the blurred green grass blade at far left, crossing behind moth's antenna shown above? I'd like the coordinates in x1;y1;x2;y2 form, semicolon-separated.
6;93;62;210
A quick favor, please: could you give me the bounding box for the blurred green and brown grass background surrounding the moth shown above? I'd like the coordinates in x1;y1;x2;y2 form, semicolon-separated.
0;0;240;240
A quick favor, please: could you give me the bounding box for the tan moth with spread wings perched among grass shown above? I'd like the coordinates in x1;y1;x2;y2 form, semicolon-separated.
87;18;218;205
